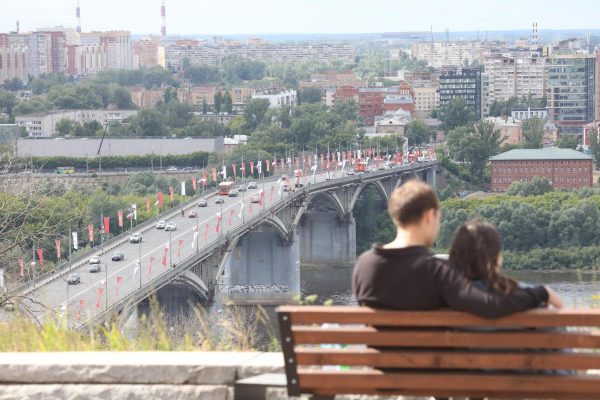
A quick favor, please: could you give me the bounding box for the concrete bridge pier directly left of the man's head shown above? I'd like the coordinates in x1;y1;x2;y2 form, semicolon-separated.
298;211;356;267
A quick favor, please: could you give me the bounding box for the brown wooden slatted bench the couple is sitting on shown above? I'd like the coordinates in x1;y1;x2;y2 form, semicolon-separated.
277;306;600;399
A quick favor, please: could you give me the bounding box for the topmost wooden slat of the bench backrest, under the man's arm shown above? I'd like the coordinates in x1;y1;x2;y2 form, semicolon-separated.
277;306;600;328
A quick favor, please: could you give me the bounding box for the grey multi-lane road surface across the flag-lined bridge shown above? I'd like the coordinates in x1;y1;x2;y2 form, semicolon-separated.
22;166;352;321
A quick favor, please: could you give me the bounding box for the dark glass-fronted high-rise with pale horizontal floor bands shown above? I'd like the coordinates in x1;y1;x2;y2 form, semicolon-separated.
439;68;482;120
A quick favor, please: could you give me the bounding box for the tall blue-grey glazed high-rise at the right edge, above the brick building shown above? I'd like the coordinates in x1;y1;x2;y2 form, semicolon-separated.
546;54;597;140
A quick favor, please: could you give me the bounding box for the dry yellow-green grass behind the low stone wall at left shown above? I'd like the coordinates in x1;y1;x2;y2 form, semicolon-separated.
0;298;280;352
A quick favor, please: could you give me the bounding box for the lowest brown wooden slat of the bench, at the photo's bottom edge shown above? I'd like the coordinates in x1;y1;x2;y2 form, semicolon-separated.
298;368;600;398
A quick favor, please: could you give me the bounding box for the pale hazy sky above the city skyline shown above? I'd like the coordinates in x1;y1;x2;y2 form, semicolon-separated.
0;0;600;34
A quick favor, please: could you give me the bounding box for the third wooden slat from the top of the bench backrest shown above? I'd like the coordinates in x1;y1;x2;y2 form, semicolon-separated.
295;348;600;370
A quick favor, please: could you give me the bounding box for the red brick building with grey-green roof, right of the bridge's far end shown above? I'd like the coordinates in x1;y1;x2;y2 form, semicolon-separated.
490;147;593;192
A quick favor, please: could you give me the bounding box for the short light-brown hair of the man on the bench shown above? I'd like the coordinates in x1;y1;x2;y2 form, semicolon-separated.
388;179;440;226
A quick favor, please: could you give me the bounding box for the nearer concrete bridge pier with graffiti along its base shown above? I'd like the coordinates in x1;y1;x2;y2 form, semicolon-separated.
216;225;300;304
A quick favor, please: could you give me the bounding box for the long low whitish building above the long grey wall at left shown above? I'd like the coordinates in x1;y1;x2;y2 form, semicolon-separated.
15;110;137;137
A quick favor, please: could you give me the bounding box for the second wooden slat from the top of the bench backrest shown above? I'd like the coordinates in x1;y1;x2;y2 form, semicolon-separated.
292;326;600;349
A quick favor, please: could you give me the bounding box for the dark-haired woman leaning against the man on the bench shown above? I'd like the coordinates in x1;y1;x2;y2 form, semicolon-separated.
449;218;563;308
